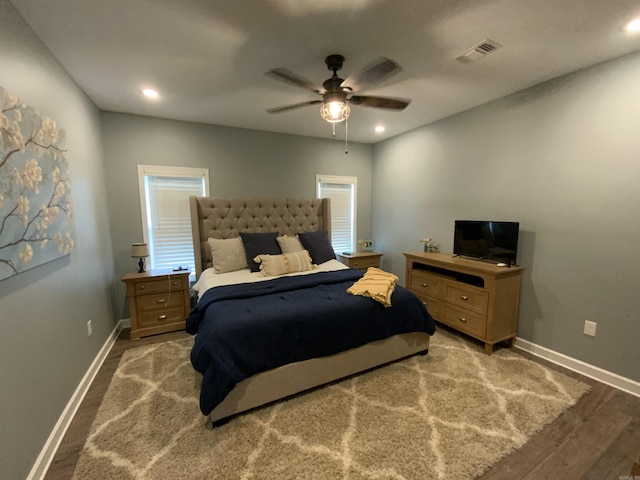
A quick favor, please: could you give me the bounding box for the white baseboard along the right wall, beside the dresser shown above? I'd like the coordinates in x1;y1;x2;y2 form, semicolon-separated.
514;337;640;397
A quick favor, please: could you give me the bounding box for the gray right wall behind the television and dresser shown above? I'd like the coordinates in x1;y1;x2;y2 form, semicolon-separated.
373;54;640;381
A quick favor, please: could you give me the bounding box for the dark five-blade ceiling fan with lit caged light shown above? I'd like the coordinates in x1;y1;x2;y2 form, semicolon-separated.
267;54;411;124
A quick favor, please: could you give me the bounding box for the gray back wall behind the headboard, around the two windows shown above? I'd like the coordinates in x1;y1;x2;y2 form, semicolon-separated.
102;112;373;318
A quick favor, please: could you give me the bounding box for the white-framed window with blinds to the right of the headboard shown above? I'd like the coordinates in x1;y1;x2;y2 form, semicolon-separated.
316;175;358;253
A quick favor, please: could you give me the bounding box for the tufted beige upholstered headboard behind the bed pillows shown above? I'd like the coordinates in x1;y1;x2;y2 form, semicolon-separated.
189;197;331;278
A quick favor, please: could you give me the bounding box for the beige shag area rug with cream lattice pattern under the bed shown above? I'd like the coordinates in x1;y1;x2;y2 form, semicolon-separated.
73;329;589;480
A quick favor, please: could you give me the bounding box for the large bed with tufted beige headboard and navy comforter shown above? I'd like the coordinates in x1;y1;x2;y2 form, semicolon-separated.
187;197;435;426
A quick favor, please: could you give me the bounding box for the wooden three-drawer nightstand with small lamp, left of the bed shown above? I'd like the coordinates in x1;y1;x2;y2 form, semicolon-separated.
122;270;191;340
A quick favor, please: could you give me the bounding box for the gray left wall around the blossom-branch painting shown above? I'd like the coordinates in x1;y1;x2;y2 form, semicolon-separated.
0;0;117;479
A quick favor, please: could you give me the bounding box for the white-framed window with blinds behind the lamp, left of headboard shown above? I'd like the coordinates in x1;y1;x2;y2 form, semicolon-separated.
138;165;209;278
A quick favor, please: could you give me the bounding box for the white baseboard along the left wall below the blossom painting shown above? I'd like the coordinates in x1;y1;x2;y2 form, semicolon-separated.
27;320;123;480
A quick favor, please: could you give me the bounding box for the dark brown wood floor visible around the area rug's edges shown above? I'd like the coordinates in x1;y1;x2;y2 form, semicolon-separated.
45;330;640;480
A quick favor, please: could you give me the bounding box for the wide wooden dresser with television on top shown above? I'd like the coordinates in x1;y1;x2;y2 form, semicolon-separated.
404;252;524;355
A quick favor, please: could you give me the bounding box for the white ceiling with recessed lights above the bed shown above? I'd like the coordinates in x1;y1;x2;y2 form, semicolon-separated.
11;0;640;143
